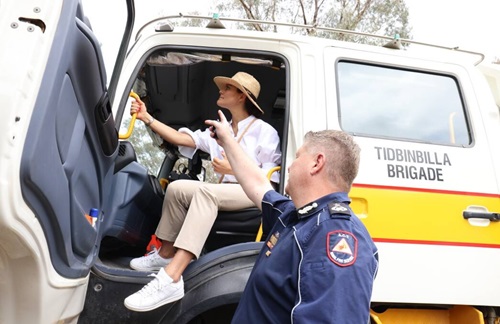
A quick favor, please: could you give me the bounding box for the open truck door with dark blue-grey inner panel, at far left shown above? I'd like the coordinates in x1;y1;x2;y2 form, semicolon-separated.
0;0;133;323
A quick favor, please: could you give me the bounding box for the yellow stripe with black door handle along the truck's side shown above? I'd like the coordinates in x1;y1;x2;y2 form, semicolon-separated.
350;184;500;248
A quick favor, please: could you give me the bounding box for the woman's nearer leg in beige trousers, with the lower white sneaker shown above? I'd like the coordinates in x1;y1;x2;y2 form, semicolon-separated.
124;182;253;311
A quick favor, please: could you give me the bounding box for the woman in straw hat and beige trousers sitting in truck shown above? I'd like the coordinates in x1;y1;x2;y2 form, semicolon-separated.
125;72;281;312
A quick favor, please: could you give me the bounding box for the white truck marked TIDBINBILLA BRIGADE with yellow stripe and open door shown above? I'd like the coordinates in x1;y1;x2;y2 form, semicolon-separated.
0;0;500;323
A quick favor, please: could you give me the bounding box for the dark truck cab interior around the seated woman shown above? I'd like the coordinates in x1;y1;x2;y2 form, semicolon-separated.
99;49;288;269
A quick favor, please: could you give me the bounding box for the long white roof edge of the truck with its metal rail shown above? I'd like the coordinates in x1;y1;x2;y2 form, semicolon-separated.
135;13;485;65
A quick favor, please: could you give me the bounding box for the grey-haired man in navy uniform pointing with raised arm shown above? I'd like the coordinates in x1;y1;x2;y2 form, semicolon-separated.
206;112;378;324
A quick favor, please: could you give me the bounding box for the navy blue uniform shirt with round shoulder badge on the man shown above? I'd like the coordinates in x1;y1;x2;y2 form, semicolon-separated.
232;191;378;324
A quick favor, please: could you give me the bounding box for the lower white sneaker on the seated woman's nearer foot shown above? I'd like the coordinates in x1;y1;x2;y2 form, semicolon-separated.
124;268;184;312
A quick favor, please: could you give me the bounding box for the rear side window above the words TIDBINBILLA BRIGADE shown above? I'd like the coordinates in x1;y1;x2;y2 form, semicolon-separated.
337;61;471;145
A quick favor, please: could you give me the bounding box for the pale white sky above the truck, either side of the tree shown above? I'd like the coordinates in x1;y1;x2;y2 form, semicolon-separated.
81;0;500;68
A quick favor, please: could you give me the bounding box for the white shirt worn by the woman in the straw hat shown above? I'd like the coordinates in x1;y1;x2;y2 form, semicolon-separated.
179;115;281;183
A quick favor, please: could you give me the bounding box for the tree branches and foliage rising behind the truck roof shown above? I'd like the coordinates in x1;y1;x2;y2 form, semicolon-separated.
216;0;411;43
